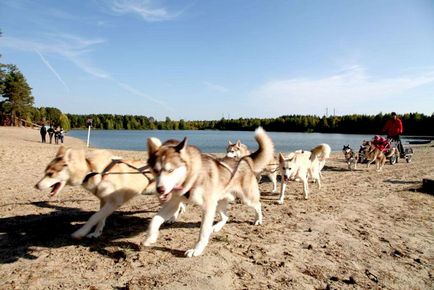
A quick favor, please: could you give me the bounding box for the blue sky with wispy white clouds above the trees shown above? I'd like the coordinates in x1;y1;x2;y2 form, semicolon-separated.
0;0;434;120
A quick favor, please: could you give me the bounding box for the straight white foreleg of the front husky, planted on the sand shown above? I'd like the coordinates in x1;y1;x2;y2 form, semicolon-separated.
185;202;217;258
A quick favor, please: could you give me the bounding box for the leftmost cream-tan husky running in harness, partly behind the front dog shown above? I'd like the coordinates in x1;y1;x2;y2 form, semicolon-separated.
35;146;163;239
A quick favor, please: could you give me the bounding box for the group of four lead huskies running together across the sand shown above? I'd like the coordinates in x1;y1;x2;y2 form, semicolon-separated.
35;127;331;257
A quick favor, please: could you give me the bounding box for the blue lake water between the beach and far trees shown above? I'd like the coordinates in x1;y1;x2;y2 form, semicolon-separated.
66;130;373;153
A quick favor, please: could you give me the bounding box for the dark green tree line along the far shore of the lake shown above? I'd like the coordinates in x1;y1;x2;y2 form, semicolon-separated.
66;113;434;136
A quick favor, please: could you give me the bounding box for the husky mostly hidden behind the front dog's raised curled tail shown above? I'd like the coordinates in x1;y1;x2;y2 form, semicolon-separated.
226;140;279;192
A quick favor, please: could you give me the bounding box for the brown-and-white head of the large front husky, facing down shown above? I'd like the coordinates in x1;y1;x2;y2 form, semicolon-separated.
148;138;188;203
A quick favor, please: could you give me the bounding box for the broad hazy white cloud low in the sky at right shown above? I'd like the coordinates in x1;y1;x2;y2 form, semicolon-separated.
250;66;434;114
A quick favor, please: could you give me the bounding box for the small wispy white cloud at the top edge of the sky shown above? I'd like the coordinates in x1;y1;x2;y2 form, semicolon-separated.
110;0;181;22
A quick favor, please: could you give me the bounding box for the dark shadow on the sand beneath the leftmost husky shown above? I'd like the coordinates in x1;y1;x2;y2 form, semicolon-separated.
0;202;154;264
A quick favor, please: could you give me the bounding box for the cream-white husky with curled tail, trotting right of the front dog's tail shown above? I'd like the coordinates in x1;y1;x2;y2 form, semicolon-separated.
278;144;331;204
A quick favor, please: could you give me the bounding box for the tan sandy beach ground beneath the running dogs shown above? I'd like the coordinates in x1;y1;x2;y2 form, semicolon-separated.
0;127;434;289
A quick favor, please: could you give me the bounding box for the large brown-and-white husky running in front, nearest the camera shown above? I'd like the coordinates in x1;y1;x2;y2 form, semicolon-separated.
143;128;274;257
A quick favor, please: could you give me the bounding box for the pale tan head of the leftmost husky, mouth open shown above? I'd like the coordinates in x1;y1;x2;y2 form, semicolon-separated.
35;146;87;196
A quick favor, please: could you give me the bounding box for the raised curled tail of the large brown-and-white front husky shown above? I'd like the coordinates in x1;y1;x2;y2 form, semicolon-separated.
250;127;274;173
